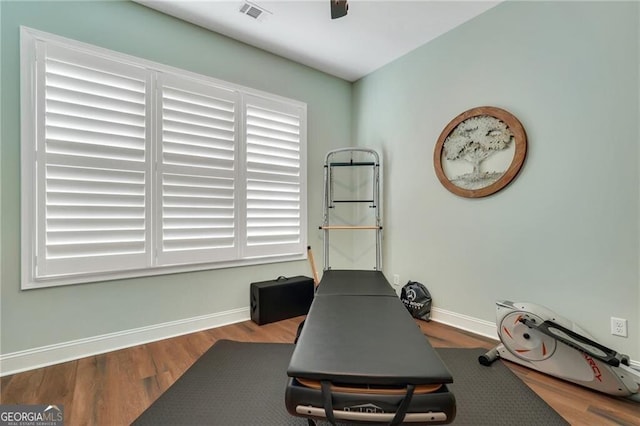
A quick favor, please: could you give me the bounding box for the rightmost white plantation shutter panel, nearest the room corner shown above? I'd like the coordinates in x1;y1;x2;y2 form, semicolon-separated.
243;96;306;257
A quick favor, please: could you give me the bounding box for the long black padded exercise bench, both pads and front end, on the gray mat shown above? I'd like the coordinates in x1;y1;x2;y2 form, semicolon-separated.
285;270;456;425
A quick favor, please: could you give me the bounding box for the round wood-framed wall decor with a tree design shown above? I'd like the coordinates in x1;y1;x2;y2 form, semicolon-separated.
433;106;527;198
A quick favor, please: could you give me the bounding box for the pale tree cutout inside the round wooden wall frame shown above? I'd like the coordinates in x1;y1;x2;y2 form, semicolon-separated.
443;115;514;189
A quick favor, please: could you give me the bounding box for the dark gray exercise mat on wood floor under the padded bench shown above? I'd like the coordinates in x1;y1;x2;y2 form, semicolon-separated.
134;340;568;426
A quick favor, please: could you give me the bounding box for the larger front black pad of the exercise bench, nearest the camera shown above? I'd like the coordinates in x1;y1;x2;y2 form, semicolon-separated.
287;294;453;385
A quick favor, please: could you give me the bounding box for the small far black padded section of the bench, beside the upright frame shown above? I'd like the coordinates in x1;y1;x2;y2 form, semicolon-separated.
316;269;397;297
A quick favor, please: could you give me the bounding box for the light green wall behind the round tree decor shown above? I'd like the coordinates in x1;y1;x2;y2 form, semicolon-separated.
353;1;640;360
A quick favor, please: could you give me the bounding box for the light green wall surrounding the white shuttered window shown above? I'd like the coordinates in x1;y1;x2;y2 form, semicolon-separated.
0;1;351;354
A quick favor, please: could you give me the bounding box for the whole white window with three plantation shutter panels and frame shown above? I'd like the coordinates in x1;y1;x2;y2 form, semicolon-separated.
21;28;307;289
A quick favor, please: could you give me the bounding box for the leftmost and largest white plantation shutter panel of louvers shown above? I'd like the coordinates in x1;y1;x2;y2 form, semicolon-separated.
36;44;149;276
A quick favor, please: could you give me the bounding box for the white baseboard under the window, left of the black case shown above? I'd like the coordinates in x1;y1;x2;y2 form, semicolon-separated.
0;307;250;377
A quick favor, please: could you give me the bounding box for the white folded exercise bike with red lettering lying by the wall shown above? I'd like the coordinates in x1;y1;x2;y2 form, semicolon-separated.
479;301;640;402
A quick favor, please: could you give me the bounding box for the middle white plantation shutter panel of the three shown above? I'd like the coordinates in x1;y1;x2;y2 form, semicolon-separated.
158;75;238;265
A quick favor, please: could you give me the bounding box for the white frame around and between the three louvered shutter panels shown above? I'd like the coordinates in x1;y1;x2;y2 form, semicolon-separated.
20;26;308;290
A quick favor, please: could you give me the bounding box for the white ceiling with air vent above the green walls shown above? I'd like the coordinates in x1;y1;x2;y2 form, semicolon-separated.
134;0;500;81
